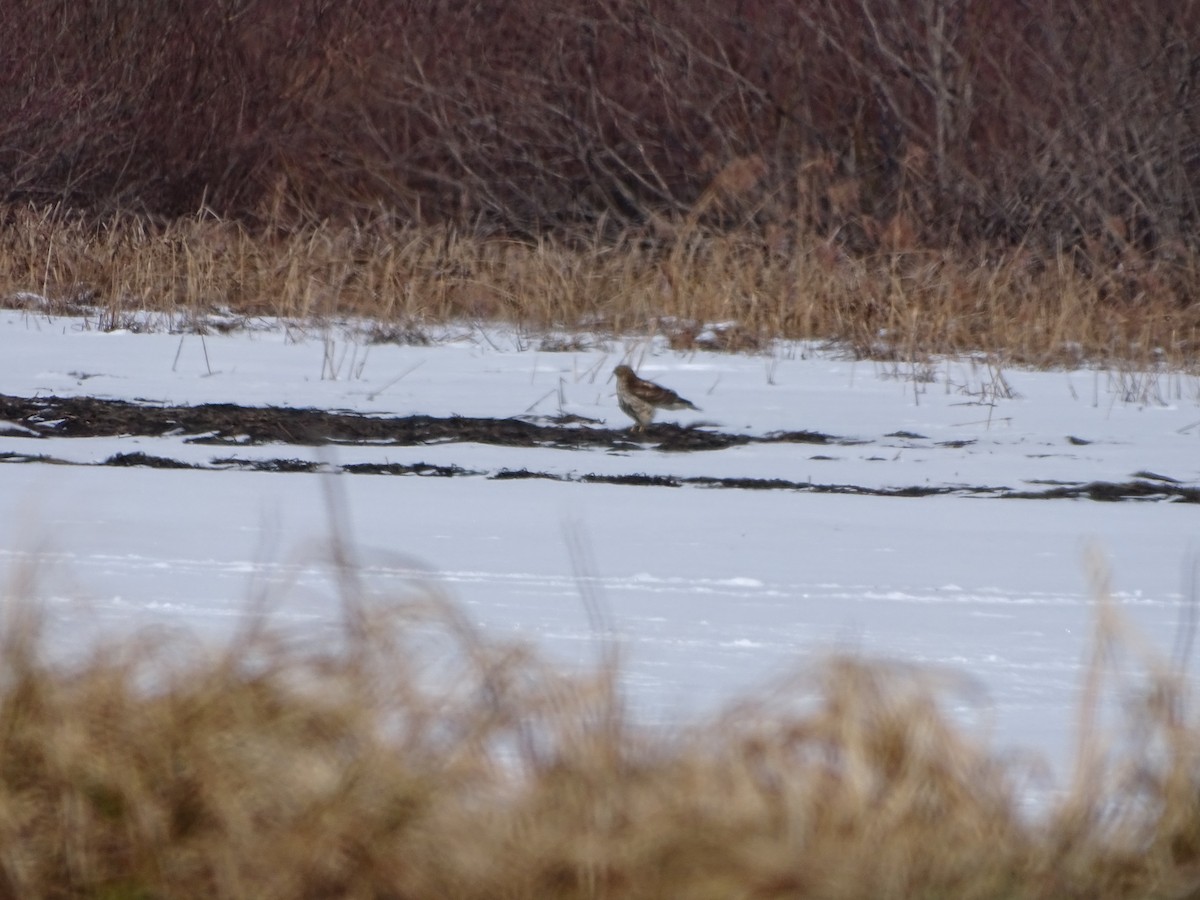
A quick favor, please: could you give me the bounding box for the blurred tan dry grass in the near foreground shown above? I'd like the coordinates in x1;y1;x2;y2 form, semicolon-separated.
0;547;1200;900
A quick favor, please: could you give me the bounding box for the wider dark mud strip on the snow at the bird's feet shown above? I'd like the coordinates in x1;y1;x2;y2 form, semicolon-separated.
0;395;840;452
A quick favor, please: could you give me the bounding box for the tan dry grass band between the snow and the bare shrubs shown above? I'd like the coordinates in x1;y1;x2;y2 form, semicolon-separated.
0;208;1200;368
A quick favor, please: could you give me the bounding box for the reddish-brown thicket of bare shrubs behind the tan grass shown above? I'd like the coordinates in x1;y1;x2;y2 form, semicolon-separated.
0;0;1200;255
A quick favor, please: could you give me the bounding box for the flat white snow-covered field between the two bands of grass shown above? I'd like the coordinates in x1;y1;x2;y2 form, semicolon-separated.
0;311;1200;796
